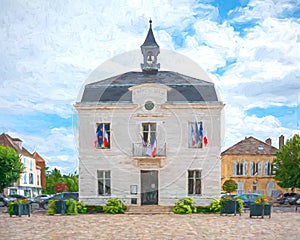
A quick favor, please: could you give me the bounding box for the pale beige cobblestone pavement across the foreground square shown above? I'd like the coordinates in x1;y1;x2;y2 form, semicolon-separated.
0;207;300;240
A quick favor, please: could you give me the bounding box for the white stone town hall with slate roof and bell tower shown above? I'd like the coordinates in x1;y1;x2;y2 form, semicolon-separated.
74;21;224;205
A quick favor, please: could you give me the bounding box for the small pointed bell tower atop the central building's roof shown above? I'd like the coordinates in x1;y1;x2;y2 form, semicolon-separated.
141;19;160;73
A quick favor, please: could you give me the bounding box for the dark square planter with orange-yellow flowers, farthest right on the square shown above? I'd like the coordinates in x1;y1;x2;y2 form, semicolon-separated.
250;196;271;218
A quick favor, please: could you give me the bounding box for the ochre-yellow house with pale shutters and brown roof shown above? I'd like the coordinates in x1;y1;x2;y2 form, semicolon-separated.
221;136;284;196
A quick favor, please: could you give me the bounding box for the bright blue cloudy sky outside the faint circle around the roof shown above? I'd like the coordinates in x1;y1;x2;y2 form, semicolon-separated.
0;0;300;174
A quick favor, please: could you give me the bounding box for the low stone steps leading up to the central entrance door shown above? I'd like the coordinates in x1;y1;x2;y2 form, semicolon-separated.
125;205;173;215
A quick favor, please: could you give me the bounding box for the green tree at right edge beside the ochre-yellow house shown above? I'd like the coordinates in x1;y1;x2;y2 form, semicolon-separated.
273;134;300;188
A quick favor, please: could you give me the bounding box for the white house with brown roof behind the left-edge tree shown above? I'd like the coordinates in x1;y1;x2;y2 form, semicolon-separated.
0;133;45;197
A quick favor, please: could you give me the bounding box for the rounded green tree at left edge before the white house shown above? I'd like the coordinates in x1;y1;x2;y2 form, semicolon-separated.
0;146;24;193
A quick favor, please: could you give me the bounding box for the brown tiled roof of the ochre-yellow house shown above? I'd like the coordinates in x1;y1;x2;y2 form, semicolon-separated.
221;137;278;156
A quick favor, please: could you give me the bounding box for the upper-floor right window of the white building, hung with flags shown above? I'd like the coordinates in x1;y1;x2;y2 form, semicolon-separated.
188;122;203;148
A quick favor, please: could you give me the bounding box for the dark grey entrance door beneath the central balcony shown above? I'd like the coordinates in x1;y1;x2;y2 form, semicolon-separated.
141;170;158;205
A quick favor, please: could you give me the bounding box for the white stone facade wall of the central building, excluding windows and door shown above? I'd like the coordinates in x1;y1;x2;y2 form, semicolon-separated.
75;83;223;205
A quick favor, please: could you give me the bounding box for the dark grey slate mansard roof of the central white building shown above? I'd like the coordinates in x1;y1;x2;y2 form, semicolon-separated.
81;71;218;103
